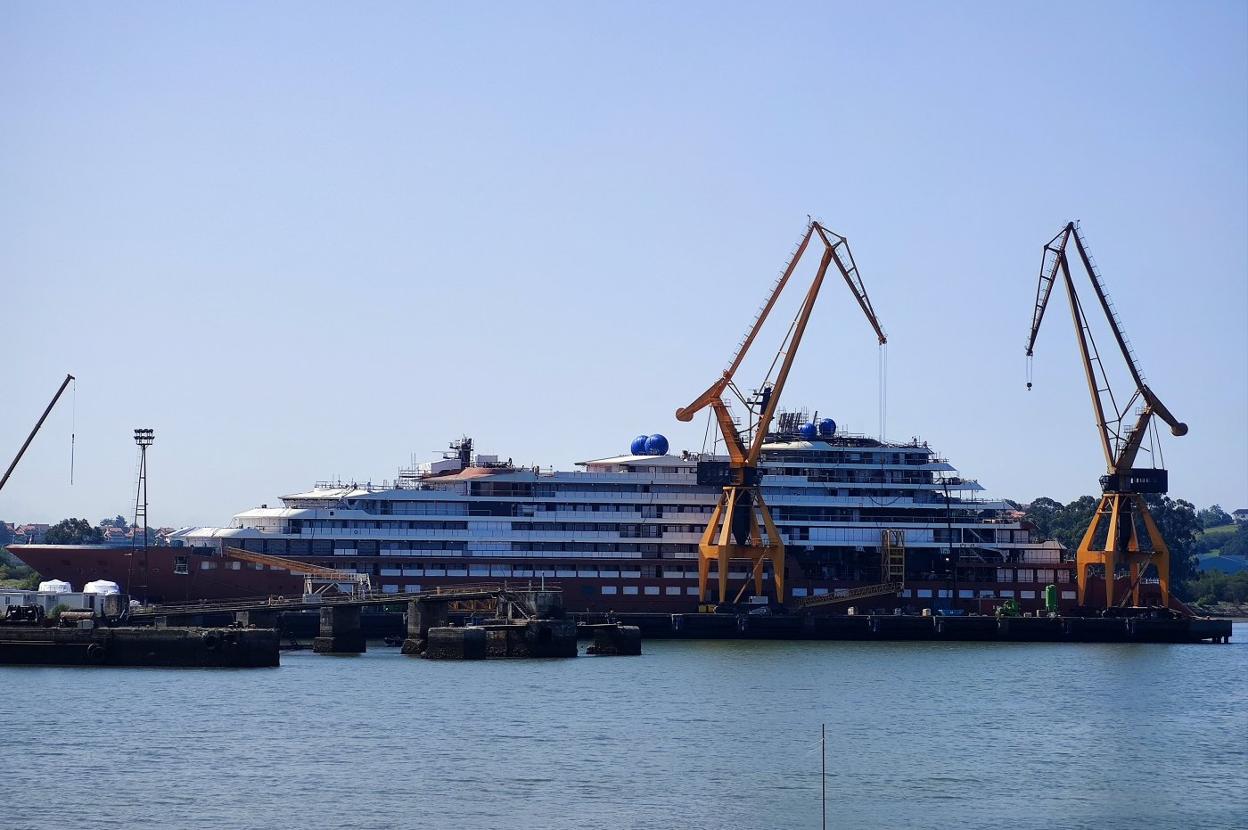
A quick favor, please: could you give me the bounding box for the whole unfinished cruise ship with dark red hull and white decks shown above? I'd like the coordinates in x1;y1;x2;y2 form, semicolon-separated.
11;412;1076;613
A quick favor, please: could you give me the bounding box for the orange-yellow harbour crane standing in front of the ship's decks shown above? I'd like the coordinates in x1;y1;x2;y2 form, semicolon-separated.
676;221;887;603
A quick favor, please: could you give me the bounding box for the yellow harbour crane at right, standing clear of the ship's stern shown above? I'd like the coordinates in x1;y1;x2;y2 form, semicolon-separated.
1027;222;1187;608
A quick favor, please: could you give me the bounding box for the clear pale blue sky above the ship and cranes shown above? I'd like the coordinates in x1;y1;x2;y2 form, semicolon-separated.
0;0;1248;525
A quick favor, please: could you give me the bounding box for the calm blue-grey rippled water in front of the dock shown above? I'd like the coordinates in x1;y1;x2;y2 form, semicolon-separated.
0;625;1248;830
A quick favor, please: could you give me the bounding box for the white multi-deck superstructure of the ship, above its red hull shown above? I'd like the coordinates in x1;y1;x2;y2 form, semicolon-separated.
175;421;1065;609
